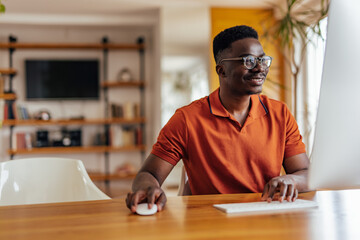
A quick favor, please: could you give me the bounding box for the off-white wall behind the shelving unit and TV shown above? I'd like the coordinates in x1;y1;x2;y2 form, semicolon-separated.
0;24;160;174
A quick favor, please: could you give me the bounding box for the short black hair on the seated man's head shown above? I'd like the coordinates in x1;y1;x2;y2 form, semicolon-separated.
213;25;259;63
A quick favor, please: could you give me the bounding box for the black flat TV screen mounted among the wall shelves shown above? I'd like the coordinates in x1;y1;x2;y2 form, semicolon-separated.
25;59;99;100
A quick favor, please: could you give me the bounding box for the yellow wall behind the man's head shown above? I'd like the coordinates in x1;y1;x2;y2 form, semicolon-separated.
210;8;285;101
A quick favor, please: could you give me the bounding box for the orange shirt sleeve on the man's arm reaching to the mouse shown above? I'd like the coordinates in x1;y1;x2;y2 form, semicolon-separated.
151;110;187;165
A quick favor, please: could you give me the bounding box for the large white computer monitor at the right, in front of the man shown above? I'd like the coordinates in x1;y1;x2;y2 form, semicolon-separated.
309;0;360;189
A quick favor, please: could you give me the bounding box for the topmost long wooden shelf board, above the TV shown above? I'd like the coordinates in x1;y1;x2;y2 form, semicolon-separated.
0;43;145;50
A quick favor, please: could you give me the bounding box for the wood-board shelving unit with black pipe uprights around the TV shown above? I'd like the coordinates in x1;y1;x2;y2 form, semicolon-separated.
0;36;146;183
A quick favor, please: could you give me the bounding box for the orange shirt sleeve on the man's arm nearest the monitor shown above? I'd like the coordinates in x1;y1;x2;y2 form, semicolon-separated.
285;106;306;158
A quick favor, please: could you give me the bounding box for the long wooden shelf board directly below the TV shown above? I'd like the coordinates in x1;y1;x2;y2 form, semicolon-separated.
0;117;145;126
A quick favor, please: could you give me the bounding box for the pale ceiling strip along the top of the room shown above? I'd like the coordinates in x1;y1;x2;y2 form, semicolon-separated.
3;0;278;15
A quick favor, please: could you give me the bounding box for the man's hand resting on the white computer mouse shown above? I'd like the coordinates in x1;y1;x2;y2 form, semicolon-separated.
126;187;166;212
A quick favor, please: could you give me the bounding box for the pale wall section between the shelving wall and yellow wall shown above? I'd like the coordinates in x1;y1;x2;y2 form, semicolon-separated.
161;5;210;187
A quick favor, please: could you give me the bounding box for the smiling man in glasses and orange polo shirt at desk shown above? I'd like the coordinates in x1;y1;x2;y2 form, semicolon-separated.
126;26;309;212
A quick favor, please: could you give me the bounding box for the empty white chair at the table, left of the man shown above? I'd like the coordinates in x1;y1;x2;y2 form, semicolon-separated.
0;158;110;206
